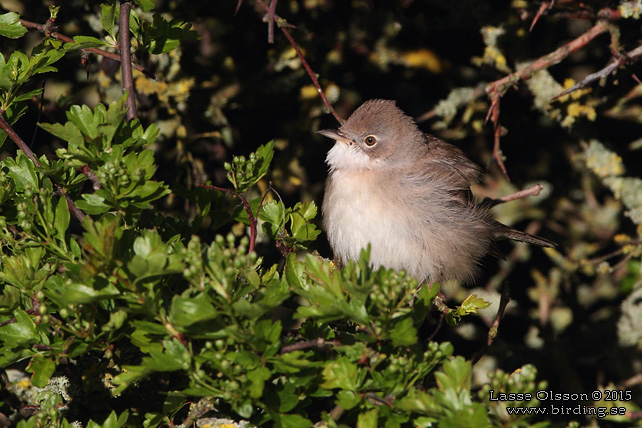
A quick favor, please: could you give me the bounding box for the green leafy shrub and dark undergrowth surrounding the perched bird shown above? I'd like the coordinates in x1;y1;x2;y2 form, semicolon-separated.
0;0;642;428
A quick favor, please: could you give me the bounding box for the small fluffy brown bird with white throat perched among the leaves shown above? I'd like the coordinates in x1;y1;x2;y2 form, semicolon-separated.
317;99;555;283
